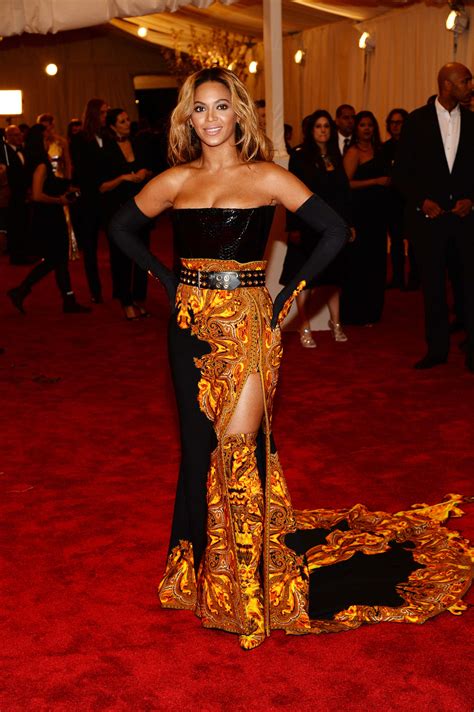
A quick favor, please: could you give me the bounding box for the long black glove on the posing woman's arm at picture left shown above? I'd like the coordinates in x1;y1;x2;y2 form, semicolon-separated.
109;198;178;308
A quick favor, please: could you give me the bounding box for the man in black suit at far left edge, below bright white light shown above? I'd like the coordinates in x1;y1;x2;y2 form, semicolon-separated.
0;124;36;265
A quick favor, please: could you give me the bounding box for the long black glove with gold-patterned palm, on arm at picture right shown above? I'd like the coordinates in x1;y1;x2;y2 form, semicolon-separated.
271;194;350;329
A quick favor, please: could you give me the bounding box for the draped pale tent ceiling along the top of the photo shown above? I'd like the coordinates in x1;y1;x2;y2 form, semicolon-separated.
0;0;446;38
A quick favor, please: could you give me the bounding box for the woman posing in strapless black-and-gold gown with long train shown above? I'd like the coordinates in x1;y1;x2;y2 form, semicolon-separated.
110;68;465;649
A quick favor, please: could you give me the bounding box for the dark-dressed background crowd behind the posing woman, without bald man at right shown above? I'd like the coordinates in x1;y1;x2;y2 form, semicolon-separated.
0;67;474;372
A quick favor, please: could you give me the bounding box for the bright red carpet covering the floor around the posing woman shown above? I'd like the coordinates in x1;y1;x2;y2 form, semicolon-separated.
0;219;474;712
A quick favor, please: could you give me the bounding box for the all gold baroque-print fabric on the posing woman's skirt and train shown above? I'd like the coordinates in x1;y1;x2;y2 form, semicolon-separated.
159;259;473;648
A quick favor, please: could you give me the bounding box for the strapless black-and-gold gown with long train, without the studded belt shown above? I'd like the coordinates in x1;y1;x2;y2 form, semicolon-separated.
159;206;472;648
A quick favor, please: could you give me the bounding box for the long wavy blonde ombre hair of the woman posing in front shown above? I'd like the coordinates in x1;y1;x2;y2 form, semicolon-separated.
168;67;273;165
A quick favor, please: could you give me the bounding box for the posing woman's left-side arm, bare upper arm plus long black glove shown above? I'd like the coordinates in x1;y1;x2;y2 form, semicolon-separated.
109;168;179;306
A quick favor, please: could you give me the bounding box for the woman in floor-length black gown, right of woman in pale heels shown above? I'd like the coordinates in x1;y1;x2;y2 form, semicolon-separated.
341;111;390;326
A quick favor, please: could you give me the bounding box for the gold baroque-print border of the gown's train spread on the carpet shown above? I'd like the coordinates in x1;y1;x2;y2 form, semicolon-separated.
295;494;474;632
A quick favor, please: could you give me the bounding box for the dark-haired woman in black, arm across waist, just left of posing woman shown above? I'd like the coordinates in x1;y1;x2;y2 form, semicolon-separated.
99;109;151;320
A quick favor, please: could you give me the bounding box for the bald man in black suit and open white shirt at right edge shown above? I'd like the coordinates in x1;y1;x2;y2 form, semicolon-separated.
394;62;474;372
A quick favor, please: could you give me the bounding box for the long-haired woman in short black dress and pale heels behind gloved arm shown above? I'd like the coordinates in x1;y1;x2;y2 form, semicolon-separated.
280;109;351;348
